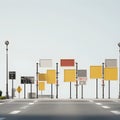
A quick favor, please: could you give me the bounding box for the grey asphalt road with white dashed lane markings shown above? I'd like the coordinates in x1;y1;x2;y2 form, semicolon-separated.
0;99;120;120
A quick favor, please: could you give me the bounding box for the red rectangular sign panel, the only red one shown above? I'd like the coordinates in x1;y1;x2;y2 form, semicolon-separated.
60;59;75;67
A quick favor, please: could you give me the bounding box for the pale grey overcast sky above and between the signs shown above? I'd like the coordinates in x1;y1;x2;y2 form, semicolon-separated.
0;0;120;97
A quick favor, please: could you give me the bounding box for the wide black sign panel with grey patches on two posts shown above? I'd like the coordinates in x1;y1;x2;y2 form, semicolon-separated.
21;76;34;84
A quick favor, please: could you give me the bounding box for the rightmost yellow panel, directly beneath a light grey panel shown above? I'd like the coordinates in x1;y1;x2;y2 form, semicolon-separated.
104;68;118;80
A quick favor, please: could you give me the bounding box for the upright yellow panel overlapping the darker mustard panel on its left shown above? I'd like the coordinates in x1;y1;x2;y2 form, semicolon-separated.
47;70;56;84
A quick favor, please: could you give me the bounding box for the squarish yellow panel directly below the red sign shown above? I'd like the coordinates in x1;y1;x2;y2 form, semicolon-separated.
64;69;76;82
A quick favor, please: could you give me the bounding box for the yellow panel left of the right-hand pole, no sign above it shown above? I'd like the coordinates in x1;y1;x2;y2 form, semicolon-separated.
90;66;102;79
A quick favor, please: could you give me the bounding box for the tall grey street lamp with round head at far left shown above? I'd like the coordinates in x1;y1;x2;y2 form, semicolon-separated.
5;41;9;99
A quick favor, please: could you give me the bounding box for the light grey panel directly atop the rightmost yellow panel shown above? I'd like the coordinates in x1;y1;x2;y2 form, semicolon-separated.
105;59;117;68
